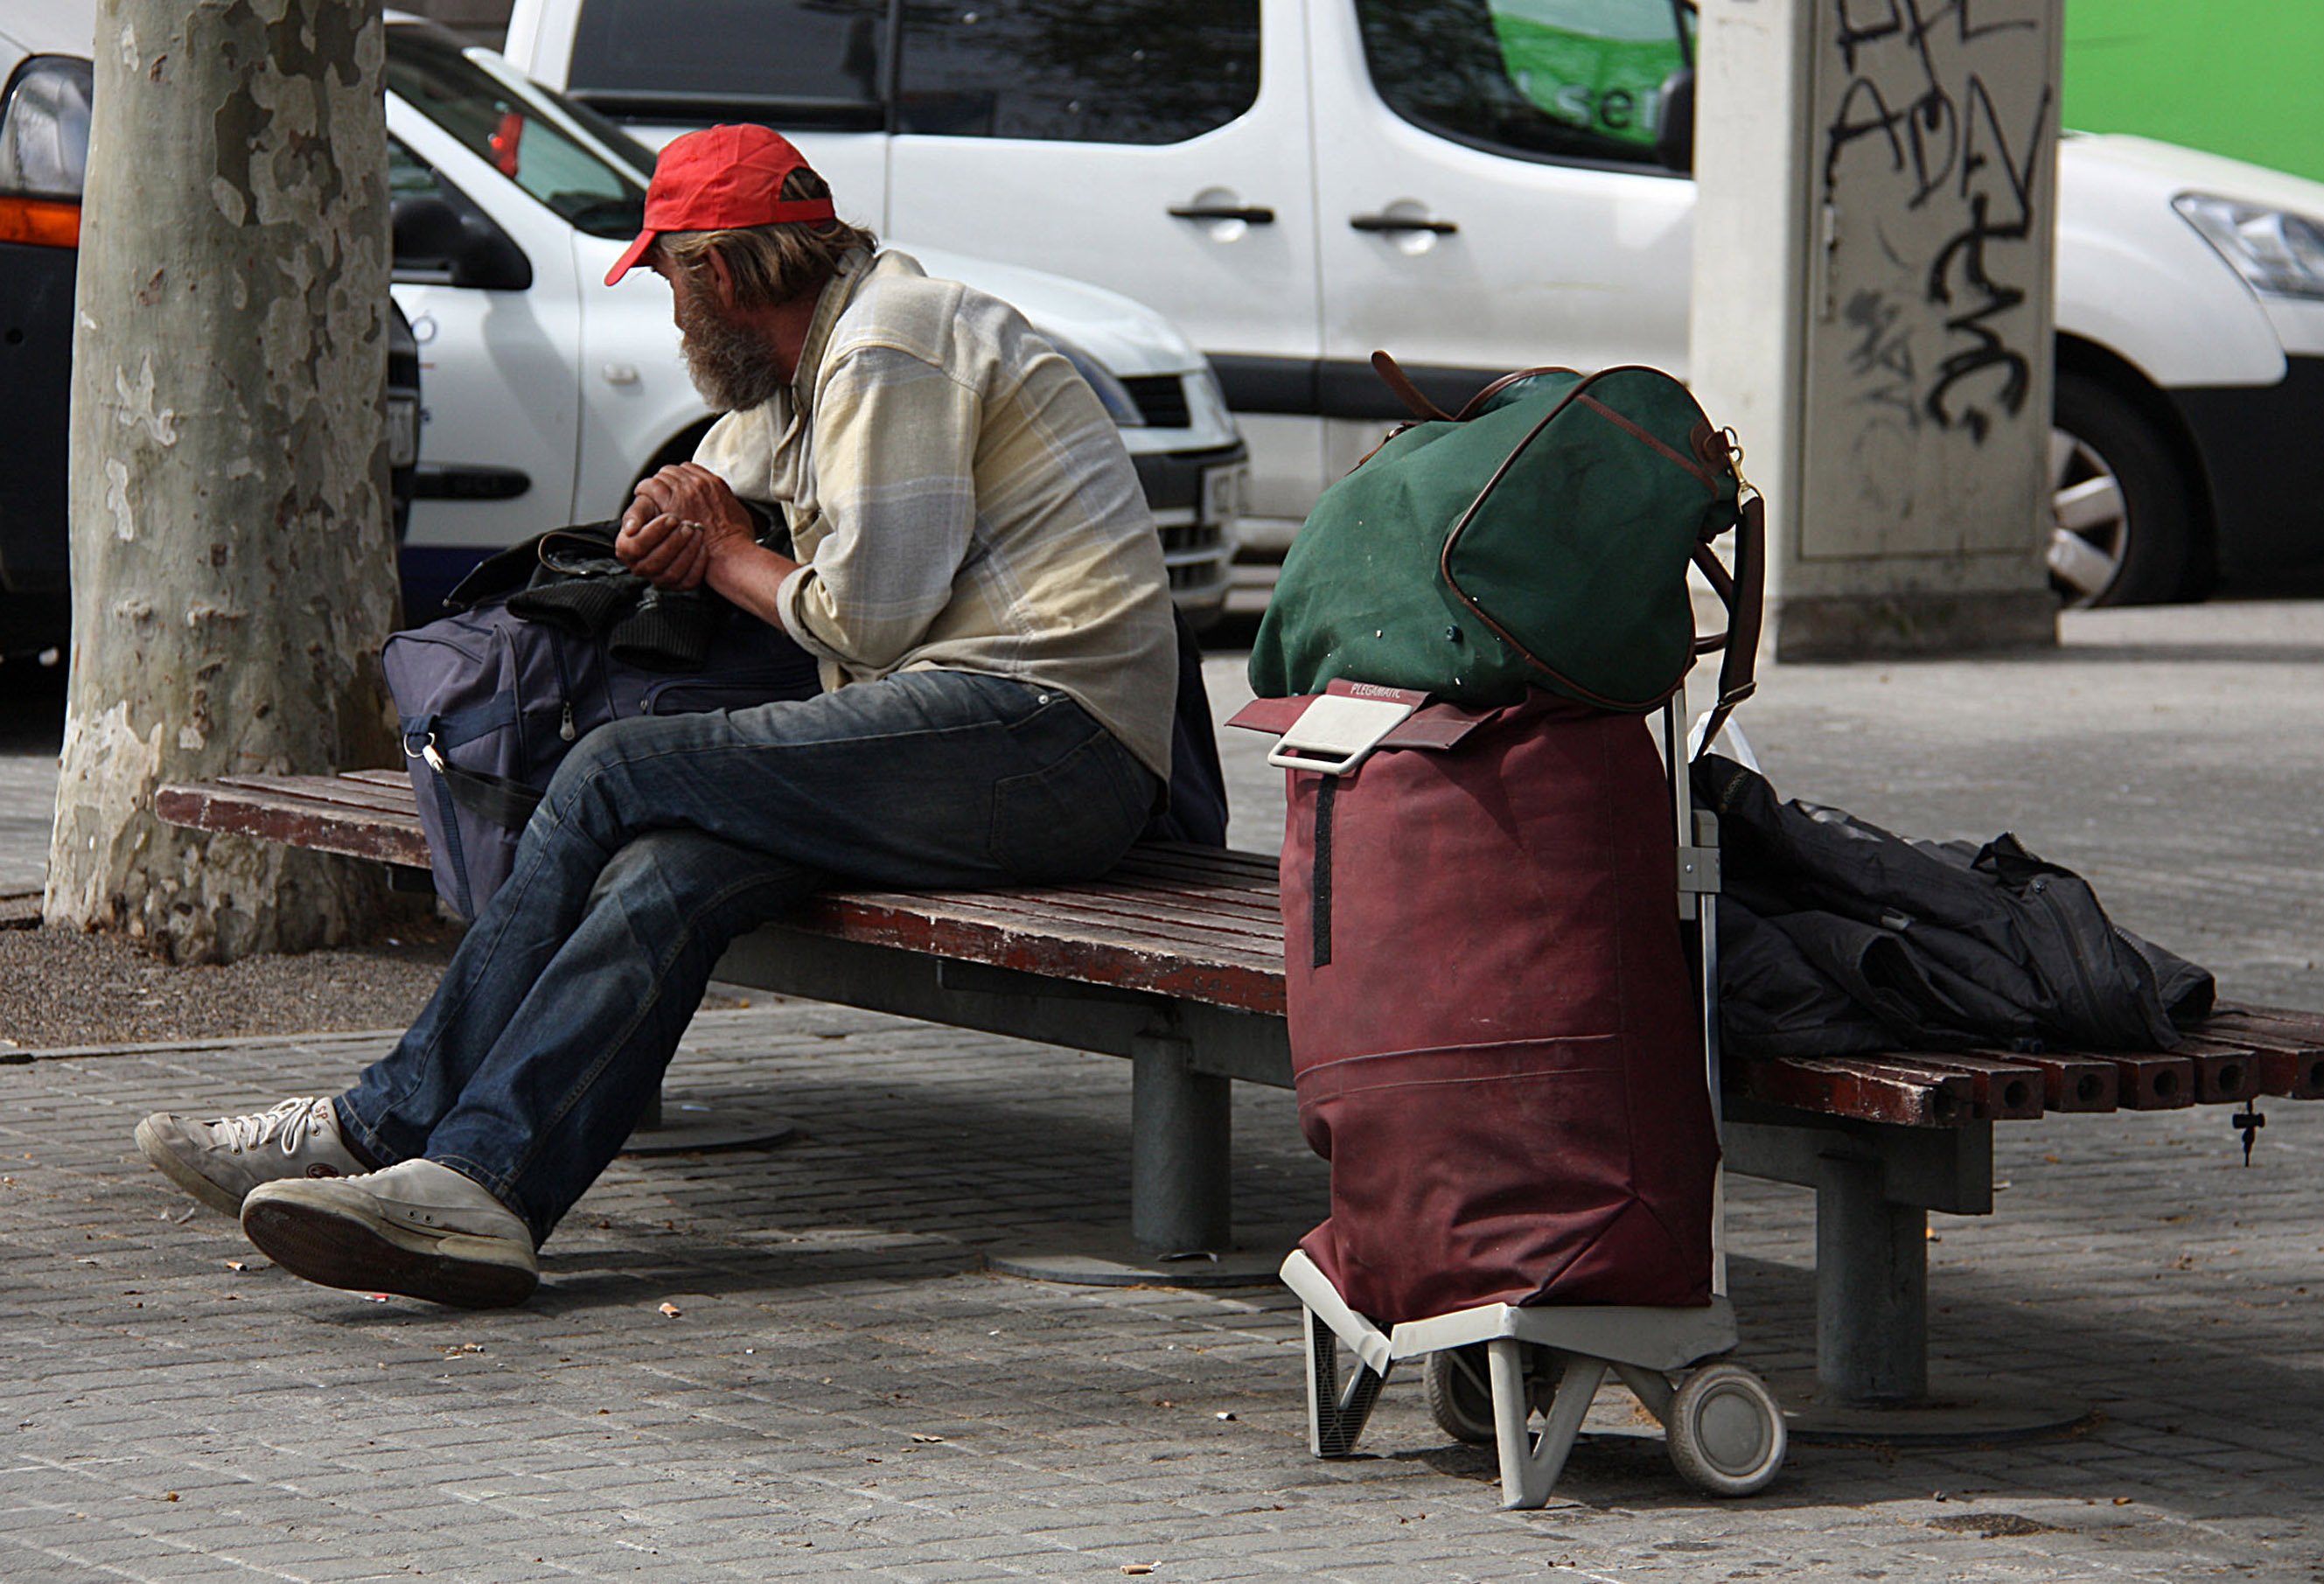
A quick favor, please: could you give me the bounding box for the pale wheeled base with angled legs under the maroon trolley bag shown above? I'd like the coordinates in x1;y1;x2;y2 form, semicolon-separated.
1283;1250;1785;1507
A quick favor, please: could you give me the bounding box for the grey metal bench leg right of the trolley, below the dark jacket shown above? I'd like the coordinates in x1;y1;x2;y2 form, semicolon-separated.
1815;1156;1929;1403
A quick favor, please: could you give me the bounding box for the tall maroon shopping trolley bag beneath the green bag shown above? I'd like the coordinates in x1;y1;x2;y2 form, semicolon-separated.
1237;683;1718;1326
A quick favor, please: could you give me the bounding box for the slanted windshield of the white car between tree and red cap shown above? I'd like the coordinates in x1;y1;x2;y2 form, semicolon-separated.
388;28;651;237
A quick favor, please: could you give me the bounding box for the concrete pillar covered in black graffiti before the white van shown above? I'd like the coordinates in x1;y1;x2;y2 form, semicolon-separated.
1690;0;2063;659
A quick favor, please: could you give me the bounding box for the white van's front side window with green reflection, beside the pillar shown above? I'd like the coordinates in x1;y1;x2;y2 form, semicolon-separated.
1357;0;1694;165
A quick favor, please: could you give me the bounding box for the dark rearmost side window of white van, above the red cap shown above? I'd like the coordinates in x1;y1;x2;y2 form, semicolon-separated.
567;0;888;132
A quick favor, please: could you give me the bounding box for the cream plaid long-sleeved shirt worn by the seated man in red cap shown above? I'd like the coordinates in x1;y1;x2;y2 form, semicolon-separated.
694;251;1176;780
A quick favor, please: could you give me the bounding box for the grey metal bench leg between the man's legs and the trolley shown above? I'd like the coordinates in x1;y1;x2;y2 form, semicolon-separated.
1129;1036;1234;1254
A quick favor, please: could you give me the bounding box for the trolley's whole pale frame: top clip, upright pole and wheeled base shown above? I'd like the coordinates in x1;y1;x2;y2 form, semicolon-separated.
1283;697;1785;1507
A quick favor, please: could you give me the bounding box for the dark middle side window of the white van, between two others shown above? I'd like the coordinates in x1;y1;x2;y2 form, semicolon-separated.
897;0;1260;144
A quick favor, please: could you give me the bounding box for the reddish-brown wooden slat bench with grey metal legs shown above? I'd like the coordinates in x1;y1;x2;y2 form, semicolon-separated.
156;771;2324;1400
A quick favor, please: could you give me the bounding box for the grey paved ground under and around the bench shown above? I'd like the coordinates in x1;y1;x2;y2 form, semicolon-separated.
0;606;2324;1584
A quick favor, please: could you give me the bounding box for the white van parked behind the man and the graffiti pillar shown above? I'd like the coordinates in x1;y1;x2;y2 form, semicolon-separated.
506;0;2324;602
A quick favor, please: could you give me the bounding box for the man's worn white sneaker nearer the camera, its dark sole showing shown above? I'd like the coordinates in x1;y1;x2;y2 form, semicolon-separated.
241;1162;541;1310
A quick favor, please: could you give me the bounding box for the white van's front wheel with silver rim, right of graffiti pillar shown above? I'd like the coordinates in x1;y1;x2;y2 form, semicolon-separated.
2049;372;2210;609
